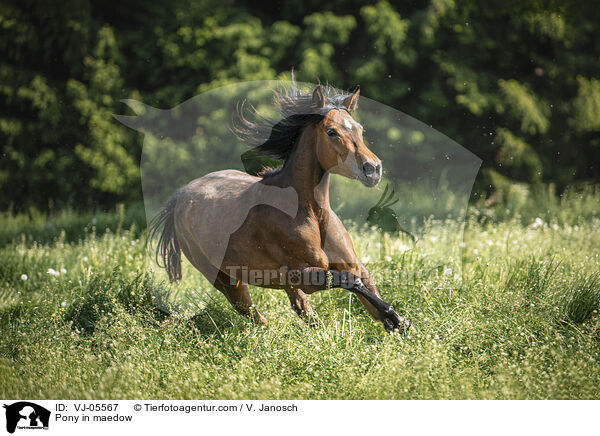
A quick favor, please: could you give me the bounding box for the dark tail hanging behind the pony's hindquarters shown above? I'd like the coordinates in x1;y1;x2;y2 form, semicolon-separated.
149;193;181;282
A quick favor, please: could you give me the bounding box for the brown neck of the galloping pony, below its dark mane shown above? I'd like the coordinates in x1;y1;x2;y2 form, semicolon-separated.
270;126;330;211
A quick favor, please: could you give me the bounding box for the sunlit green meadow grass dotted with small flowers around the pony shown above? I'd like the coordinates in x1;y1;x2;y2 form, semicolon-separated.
0;194;600;399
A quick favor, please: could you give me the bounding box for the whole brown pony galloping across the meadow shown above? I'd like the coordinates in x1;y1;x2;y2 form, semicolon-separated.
155;86;410;330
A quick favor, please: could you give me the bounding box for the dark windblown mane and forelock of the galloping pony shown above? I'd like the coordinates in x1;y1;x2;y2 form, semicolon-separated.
233;82;350;171
